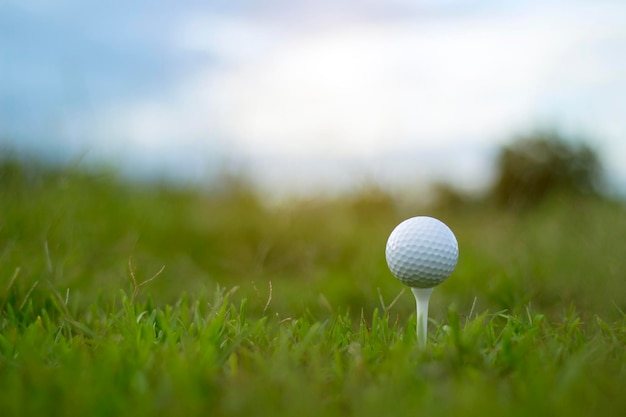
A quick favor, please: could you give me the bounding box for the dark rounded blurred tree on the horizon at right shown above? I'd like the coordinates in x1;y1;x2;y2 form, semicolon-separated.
491;131;603;208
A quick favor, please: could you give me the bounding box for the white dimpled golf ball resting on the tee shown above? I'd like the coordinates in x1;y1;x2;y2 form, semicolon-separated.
385;216;459;288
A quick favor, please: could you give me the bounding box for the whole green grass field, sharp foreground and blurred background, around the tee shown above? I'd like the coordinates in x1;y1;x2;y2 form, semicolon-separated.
0;163;626;416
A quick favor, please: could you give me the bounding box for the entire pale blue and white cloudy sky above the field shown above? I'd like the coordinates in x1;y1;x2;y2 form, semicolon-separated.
0;0;626;192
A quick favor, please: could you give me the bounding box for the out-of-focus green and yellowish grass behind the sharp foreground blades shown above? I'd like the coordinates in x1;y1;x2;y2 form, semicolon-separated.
0;156;626;317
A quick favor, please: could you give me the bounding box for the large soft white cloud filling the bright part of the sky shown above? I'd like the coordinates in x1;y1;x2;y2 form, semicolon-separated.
67;0;626;190
